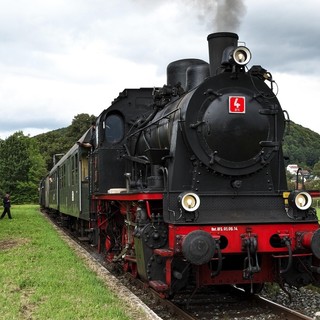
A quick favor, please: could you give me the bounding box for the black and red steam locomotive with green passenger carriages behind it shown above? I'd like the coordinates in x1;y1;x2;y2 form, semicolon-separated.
40;32;320;297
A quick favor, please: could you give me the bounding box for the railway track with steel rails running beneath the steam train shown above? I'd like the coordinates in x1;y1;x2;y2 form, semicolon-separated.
43;212;313;320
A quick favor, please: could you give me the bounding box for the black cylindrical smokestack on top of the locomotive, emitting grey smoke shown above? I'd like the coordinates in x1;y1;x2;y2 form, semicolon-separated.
207;32;239;76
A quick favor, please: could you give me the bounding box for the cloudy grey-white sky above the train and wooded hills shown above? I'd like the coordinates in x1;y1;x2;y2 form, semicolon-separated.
0;0;320;139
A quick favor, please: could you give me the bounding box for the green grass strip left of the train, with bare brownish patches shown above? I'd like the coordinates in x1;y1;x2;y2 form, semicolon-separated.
0;205;135;320
